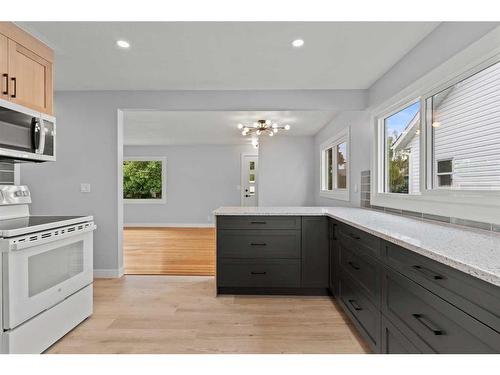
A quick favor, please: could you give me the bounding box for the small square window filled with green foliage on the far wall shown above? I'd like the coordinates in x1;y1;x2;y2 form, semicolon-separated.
123;157;166;203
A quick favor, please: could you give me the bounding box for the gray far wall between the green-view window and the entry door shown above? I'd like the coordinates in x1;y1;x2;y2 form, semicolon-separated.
124;145;255;225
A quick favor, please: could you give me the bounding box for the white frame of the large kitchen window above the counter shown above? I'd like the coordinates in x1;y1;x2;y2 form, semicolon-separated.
370;48;500;222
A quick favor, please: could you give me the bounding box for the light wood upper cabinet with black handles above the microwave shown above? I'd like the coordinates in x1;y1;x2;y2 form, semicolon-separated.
0;22;54;115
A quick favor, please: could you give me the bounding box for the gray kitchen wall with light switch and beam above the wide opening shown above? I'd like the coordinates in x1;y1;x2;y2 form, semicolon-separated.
21;90;366;271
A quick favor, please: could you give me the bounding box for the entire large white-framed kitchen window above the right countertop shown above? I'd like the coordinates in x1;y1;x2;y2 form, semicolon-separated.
370;46;500;223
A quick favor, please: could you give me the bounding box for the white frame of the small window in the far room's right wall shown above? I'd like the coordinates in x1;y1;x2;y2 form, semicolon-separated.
319;127;351;201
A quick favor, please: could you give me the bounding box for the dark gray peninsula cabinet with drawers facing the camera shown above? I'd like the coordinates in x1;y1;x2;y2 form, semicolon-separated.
217;216;329;294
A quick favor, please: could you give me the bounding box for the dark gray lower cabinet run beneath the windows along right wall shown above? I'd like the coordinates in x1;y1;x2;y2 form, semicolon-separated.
330;221;500;353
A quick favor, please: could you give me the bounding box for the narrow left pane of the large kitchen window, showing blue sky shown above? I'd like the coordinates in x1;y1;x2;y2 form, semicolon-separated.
380;102;420;194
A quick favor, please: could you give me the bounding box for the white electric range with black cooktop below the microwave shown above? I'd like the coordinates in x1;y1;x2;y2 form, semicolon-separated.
0;185;96;353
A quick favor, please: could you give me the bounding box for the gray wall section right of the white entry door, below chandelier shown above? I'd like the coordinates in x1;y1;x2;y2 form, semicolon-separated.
258;134;314;206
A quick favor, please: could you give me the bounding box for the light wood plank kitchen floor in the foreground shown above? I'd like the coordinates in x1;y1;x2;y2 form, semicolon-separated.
47;276;369;354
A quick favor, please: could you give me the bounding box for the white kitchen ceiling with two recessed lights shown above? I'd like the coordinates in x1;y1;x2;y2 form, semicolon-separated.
18;22;438;90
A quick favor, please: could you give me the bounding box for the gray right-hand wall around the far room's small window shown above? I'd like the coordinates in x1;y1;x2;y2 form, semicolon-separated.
314;111;373;206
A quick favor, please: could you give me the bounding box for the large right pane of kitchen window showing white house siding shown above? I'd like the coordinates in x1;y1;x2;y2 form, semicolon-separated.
426;62;500;190
